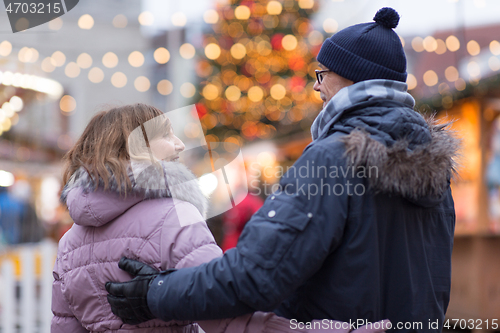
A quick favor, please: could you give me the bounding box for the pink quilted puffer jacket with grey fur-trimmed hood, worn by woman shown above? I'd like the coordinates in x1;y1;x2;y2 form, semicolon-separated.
51;162;382;333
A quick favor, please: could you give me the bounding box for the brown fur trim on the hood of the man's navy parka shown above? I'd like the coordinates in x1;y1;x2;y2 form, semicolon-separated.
341;115;460;206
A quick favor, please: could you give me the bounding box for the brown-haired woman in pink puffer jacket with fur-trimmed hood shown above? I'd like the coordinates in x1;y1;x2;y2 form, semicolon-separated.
51;104;382;333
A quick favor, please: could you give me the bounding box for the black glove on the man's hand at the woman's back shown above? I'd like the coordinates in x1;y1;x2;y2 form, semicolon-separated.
106;257;175;325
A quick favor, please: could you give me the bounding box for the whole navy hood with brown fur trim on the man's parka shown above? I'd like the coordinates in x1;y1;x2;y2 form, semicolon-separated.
332;103;460;206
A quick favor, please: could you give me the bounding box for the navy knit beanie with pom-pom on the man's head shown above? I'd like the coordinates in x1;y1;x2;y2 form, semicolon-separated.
317;7;407;83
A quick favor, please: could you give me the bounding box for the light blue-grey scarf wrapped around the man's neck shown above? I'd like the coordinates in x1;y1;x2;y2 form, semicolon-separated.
311;79;415;140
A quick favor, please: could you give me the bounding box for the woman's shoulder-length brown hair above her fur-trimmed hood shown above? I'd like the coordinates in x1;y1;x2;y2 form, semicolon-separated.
63;103;170;193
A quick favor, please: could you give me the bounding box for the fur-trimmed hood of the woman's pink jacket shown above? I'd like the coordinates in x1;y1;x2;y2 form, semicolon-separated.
61;161;208;226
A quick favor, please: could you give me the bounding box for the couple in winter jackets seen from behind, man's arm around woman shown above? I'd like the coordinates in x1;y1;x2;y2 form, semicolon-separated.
52;8;458;333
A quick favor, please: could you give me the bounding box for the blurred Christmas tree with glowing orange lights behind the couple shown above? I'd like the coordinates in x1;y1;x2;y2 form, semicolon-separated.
197;0;324;146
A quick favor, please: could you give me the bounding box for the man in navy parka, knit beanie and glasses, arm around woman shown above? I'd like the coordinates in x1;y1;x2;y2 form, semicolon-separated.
107;8;458;332
